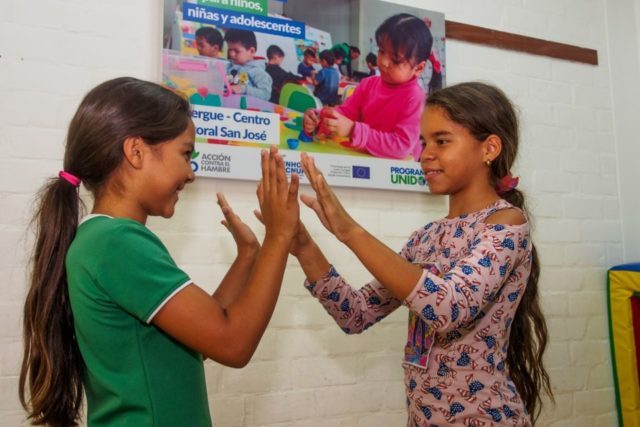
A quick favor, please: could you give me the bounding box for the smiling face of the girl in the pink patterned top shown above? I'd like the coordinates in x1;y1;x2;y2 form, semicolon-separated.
420;106;489;195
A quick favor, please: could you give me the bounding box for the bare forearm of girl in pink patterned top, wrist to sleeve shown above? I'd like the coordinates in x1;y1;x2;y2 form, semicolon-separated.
343;226;422;301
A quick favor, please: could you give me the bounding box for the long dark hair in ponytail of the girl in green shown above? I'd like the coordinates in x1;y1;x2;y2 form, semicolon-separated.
19;77;190;426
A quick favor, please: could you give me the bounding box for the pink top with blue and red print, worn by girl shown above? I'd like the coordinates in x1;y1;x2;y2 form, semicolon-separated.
305;199;532;427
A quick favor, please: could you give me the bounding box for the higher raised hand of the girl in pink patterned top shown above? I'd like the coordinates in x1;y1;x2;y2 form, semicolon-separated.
300;152;362;243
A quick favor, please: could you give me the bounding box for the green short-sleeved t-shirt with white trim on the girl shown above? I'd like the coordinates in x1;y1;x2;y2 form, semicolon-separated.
66;216;211;427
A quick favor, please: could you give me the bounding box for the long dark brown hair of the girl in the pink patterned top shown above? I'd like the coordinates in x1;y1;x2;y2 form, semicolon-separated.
427;82;553;422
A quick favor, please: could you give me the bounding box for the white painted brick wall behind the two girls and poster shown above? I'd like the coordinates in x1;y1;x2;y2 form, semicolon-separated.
0;0;624;427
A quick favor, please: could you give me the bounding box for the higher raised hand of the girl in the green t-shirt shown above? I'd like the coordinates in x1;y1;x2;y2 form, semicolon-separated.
257;146;300;240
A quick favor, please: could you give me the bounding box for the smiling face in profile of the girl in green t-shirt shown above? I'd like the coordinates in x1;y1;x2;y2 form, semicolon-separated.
140;120;195;218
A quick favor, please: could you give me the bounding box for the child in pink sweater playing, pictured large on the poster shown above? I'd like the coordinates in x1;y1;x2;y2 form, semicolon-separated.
303;13;433;160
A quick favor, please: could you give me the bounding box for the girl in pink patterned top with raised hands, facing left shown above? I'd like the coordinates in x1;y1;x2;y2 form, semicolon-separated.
291;83;551;427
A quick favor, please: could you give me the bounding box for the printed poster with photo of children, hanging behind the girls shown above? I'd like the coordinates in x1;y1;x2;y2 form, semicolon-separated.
162;0;446;191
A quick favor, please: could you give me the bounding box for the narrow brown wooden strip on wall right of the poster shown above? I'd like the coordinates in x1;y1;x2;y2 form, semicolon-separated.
445;21;598;65
